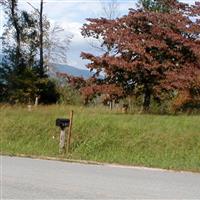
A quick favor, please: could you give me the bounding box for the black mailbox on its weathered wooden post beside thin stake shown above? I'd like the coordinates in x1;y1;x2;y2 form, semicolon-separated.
56;119;70;153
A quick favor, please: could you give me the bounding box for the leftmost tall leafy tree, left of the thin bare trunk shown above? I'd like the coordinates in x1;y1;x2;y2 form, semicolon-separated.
0;0;35;102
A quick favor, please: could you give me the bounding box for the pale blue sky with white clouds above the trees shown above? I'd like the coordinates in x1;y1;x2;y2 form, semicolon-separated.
0;0;195;69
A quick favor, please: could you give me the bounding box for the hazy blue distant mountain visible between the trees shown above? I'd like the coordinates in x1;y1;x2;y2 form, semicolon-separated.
50;63;94;78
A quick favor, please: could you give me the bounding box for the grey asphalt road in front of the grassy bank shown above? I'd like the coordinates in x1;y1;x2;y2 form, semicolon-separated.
1;156;200;199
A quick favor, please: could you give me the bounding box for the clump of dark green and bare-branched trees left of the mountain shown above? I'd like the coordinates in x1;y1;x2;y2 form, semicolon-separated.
0;0;72;103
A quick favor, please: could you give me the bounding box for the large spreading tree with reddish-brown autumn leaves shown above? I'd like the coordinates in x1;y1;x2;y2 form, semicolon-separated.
81;1;200;111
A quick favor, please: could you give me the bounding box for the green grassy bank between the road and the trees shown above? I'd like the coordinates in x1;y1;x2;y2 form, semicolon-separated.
0;106;200;172
